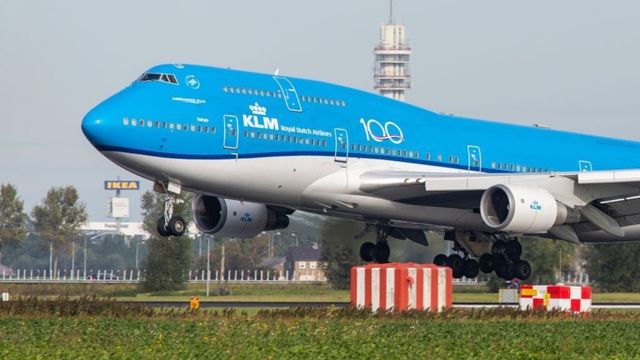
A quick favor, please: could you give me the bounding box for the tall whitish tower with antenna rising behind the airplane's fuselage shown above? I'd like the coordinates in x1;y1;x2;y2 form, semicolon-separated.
373;1;411;101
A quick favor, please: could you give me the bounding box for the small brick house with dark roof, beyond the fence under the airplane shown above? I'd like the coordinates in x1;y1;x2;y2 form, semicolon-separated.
285;245;327;281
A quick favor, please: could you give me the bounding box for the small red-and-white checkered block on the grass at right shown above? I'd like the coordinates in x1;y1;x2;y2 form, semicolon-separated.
520;285;591;313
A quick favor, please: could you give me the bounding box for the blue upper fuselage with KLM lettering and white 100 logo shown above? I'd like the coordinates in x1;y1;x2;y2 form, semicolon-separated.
82;65;640;177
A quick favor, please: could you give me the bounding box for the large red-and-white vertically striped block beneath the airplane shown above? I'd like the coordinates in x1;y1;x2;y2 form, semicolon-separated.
351;263;453;311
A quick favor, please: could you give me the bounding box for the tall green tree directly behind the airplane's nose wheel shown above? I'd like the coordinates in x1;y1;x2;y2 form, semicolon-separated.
142;191;192;291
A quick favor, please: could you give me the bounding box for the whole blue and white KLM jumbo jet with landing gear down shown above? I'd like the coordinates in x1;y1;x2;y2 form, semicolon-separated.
82;64;640;280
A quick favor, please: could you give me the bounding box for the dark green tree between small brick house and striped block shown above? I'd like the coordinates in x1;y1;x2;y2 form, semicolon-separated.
320;218;362;289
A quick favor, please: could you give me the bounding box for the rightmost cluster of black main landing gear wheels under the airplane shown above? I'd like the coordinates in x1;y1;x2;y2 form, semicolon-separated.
480;238;531;280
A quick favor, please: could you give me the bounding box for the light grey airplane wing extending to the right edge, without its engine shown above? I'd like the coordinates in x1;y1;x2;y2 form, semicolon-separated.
359;170;640;242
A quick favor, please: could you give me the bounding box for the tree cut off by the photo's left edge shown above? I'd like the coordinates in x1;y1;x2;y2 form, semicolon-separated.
0;184;27;264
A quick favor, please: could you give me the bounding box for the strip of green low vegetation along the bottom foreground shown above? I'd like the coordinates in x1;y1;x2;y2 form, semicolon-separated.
0;299;640;359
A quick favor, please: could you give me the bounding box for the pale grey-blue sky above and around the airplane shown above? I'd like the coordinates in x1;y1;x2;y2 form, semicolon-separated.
0;0;640;221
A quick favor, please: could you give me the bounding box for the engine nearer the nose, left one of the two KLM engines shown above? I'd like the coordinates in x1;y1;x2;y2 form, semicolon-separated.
191;195;289;238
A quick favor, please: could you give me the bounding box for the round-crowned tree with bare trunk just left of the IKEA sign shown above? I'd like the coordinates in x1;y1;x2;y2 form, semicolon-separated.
31;186;87;274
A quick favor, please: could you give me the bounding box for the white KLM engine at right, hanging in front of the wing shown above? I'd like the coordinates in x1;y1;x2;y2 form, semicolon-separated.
480;185;567;233
